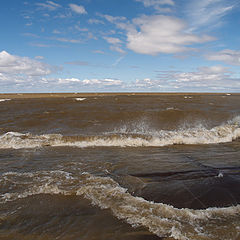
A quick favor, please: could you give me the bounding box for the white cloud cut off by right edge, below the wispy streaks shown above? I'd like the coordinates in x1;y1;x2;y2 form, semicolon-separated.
205;49;240;66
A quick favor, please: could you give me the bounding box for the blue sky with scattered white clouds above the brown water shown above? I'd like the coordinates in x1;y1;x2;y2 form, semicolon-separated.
0;0;240;93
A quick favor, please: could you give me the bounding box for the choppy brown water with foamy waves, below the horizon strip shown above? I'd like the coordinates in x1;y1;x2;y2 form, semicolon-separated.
0;94;240;240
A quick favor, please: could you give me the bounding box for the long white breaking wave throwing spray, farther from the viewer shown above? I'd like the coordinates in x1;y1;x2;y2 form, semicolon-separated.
0;116;240;149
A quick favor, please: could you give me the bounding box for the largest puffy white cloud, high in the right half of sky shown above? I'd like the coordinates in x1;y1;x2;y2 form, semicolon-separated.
127;15;214;55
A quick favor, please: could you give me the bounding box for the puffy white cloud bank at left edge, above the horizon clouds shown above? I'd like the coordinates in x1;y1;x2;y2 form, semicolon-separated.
0;51;52;76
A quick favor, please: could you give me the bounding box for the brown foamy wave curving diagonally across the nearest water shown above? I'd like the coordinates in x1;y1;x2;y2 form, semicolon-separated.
0;171;240;240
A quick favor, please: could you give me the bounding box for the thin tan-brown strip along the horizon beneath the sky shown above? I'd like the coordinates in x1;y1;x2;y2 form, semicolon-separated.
0;92;237;99
